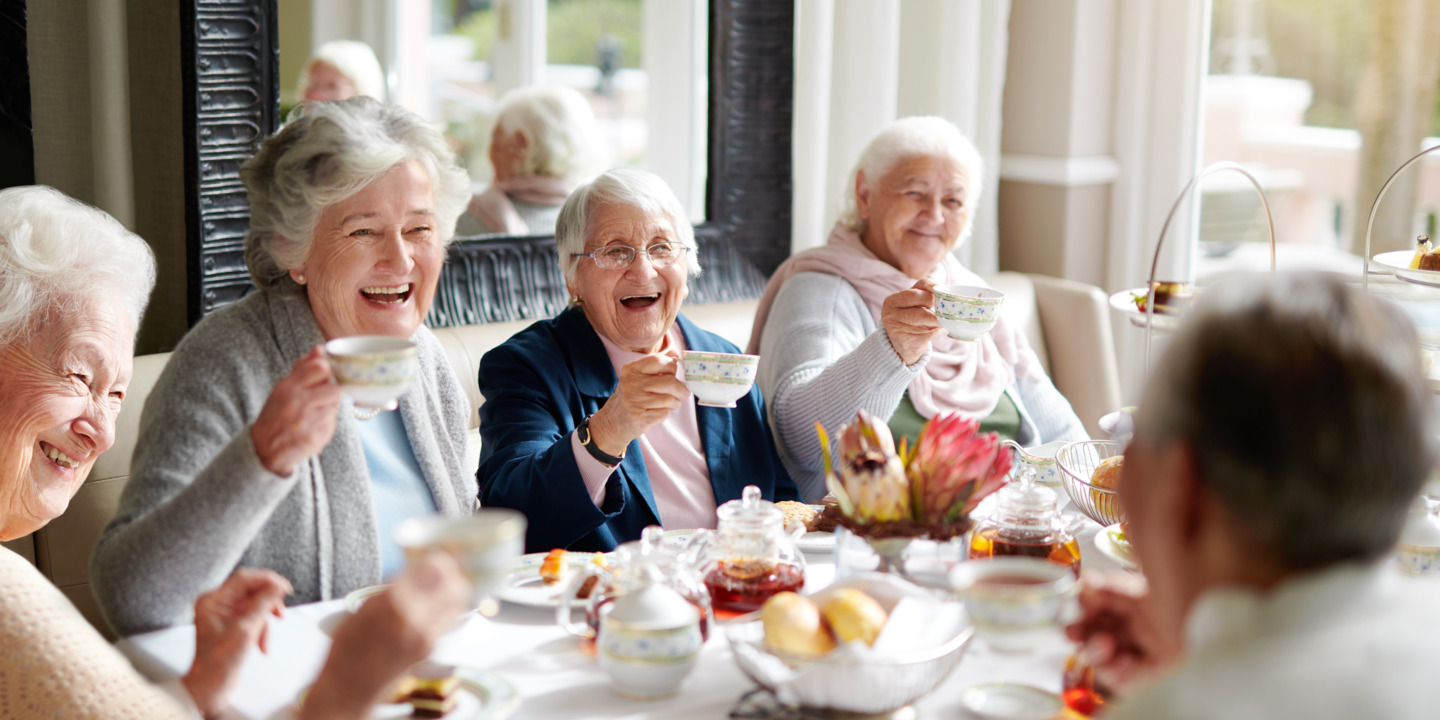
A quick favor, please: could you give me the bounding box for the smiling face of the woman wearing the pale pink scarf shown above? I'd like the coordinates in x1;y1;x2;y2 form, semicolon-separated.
855;156;971;279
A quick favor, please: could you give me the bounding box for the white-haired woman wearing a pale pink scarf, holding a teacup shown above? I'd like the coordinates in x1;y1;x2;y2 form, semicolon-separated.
750;117;1084;500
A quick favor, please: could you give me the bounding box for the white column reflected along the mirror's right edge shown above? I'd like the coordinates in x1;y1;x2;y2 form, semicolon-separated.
641;0;710;223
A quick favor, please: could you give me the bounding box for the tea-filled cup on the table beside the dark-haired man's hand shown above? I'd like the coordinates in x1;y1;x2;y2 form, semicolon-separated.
950;557;1079;651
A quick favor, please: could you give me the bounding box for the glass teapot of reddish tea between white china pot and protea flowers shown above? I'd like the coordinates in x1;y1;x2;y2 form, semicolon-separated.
690;485;805;613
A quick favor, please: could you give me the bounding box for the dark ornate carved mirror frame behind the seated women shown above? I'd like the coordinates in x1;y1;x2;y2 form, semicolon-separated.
181;0;795;327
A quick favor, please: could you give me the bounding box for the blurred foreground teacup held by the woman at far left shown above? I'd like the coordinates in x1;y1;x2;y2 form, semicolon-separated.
395;507;526;606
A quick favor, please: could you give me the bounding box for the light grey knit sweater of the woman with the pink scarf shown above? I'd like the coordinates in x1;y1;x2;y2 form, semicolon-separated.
756;272;1086;503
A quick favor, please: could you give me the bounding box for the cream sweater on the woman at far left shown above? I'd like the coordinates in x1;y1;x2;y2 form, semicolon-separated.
0;549;197;720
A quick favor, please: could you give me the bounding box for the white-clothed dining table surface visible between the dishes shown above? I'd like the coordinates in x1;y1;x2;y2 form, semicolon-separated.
117;518;1125;720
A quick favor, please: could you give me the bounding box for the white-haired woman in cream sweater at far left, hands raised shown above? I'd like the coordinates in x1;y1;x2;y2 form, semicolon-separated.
0;187;465;720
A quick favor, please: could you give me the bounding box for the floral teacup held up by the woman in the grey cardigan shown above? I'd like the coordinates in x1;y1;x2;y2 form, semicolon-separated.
325;336;419;410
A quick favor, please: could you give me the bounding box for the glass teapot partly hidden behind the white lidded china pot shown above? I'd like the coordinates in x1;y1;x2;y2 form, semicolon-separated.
554;526;713;642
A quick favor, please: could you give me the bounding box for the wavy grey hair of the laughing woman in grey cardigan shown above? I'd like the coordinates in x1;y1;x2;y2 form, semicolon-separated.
240;98;469;289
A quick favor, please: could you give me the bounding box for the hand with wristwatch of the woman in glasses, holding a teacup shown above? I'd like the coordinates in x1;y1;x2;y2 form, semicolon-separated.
590;351;690;455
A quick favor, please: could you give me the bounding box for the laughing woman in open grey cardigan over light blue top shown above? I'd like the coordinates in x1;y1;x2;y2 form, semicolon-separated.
91;98;477;635
